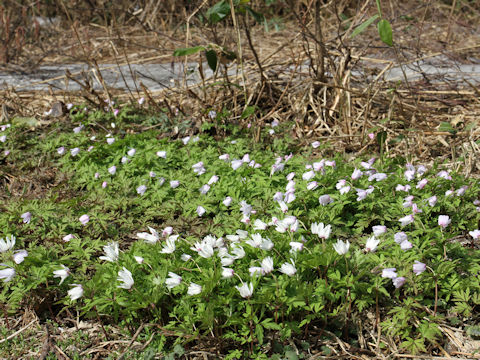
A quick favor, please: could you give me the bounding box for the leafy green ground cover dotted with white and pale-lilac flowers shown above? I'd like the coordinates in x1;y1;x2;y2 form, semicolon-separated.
0;107;480;359
